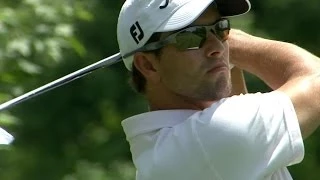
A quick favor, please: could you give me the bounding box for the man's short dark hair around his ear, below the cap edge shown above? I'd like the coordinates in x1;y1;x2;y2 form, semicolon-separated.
130;33;162;94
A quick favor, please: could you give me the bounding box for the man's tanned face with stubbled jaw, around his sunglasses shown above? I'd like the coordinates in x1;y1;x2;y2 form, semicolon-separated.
159;7;231;101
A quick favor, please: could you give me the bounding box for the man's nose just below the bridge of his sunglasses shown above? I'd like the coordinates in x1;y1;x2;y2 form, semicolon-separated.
203;33;228;57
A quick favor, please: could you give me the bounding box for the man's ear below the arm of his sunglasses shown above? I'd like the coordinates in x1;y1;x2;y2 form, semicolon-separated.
133;52;160;83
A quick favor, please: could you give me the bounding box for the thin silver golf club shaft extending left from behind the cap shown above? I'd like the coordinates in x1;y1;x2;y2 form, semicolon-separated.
0;53;122;111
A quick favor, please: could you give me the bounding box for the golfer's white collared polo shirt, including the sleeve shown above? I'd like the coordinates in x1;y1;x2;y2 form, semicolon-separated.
122;92;304;180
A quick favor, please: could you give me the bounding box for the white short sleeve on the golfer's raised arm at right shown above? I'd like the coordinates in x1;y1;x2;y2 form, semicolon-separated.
190;91;304;179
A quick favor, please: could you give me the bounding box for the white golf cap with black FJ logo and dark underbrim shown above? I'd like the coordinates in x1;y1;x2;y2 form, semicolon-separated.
117;0;251;70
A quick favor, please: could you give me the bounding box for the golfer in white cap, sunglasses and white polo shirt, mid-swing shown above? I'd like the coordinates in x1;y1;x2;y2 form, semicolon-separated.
118;0;320;180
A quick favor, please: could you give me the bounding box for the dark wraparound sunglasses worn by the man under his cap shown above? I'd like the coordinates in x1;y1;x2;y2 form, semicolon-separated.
123;18;230;58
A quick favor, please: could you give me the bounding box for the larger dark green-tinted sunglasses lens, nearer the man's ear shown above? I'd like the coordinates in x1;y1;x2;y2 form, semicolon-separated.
175;27;207;51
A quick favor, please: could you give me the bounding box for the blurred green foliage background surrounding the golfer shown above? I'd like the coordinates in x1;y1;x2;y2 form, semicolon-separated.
0;0;320;180
